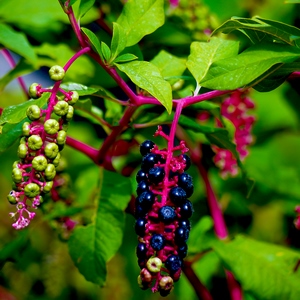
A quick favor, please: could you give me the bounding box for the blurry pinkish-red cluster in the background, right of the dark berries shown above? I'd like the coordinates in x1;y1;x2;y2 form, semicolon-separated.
212;90;255;177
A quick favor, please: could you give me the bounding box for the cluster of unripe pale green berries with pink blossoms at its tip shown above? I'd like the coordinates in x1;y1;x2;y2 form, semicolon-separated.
7;66;79;229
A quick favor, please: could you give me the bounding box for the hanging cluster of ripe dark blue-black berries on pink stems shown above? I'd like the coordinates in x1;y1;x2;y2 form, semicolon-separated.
135;127;194;296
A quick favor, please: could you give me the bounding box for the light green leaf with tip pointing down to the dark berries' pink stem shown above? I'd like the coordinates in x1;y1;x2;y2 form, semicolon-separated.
115;61;172;113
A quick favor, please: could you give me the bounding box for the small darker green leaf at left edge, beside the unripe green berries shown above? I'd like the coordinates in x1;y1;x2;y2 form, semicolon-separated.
0;119;29;153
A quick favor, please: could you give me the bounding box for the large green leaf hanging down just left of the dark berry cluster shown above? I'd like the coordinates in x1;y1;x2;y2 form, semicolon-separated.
68;169;131;285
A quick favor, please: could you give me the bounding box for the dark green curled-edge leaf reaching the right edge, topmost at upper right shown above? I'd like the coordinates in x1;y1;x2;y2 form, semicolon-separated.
213;17;300;46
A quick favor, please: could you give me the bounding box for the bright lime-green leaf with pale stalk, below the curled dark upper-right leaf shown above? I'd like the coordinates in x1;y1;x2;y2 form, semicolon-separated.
187;38;239;83
